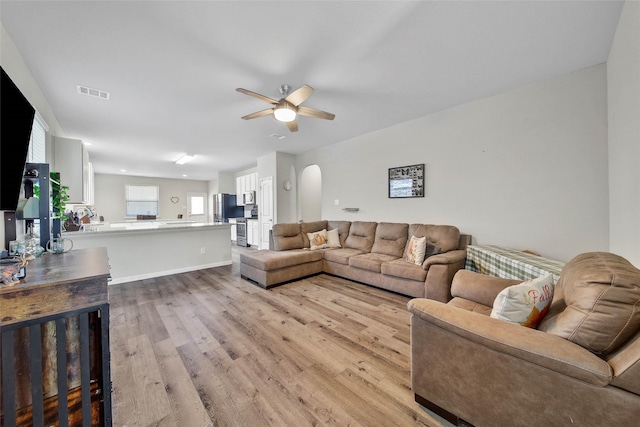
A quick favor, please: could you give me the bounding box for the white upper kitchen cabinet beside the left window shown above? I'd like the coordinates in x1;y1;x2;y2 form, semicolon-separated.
52;136;93;204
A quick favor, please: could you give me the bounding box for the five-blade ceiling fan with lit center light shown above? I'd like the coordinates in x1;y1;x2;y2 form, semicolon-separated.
236;85;335;132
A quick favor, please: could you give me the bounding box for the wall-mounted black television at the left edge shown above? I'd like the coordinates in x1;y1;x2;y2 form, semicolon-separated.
0;67;35;211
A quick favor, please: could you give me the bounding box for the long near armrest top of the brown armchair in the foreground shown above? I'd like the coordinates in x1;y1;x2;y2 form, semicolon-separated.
408;298;613;387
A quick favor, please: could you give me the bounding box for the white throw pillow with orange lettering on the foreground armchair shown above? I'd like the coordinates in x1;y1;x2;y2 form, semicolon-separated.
491;273;554;329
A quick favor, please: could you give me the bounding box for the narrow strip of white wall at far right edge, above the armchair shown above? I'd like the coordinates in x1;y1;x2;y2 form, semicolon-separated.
607;1;640;268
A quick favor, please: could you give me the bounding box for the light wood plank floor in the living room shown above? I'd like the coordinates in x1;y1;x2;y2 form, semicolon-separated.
109;248;450;427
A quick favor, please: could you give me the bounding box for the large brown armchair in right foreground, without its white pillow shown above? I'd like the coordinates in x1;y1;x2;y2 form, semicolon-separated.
408;253;640;427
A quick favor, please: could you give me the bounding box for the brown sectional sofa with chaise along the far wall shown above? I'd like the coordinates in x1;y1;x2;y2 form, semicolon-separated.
240;221;471;302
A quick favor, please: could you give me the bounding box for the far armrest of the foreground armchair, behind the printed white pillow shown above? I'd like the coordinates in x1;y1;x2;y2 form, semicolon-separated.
451;270;522;307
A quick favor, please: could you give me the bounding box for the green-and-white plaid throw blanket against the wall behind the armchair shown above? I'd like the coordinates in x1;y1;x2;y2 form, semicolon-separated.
465;245;564;283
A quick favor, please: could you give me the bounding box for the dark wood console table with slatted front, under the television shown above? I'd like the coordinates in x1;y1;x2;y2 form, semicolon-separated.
0;248;112;427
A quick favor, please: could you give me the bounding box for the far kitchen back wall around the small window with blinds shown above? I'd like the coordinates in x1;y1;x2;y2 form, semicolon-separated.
94;173;209;221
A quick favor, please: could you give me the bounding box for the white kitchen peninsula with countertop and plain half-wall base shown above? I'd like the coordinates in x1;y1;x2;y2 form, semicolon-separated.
62;220;231;284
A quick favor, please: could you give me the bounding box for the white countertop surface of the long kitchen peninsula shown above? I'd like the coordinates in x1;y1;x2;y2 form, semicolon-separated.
62;220;230;237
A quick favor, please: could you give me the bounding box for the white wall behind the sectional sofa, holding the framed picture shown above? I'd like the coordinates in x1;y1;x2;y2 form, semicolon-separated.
297;64;609;261
